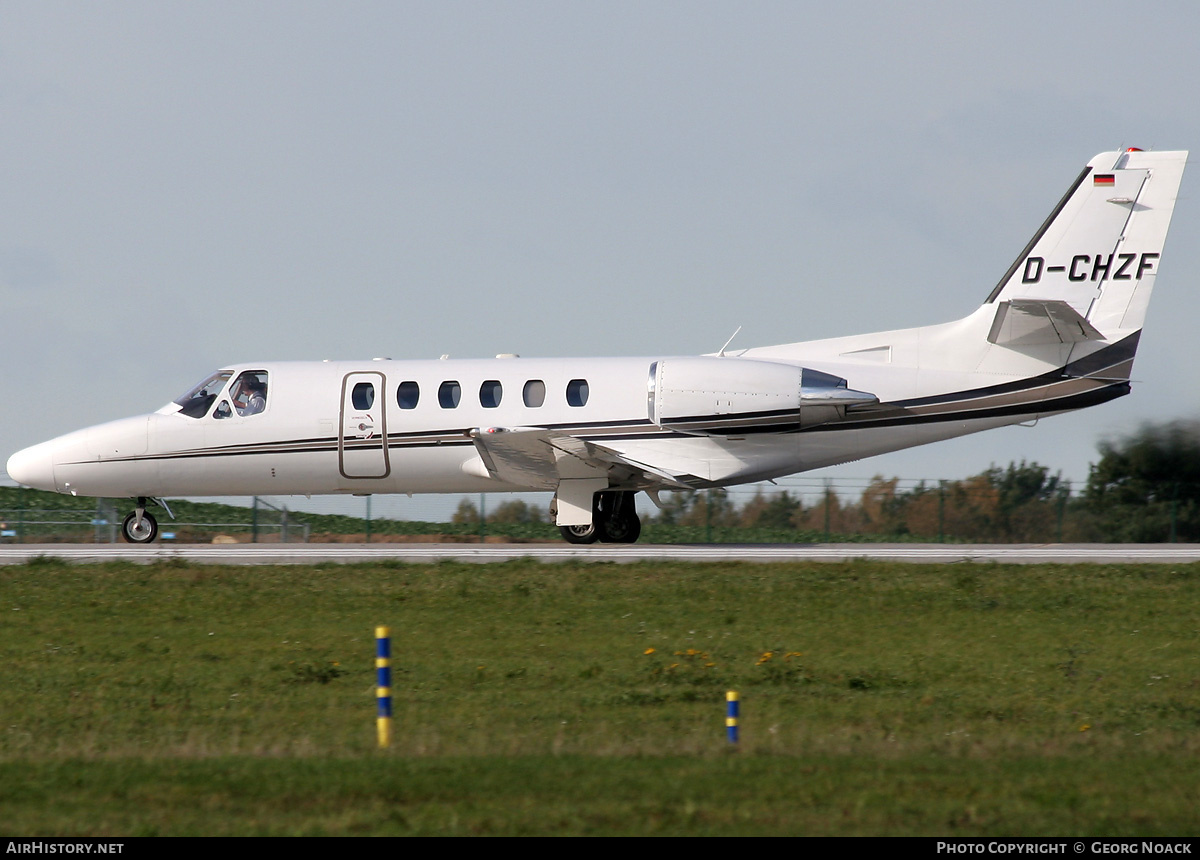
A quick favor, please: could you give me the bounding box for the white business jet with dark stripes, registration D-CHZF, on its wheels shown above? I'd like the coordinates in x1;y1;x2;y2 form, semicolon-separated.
7;149;1187;543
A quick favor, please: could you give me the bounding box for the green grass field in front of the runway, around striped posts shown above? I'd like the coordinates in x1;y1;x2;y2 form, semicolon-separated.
0;559;1200;836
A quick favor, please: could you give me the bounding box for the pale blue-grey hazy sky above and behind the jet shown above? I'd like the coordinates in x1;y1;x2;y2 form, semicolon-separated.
0;0;1200;506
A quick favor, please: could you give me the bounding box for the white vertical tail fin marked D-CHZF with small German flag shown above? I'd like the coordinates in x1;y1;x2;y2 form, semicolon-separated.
988;149;1188;343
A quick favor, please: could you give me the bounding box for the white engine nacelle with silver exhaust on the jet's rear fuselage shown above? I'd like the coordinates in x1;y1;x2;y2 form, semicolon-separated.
646;356;878;437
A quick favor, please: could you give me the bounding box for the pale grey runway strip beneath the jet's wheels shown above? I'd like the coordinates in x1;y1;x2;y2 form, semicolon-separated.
0;543;1200;565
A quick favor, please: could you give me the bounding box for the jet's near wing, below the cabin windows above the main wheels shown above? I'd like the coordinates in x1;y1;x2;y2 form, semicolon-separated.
470;427;702;489
